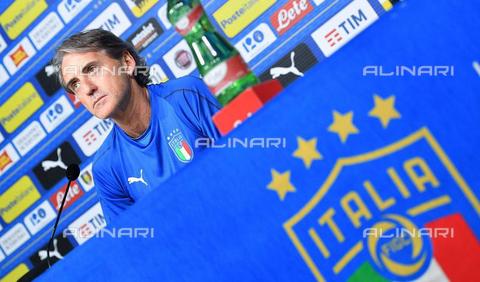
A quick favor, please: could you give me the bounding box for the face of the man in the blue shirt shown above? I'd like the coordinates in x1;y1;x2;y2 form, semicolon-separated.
61;51;131;119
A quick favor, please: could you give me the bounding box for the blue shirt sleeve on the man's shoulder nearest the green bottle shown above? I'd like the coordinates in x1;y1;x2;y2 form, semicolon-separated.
160;76;222;139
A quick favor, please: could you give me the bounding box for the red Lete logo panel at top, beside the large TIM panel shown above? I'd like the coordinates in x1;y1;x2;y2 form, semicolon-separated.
270;0;313;35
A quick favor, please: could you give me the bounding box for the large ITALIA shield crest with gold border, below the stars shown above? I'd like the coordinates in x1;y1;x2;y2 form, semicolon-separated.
283;128;480;281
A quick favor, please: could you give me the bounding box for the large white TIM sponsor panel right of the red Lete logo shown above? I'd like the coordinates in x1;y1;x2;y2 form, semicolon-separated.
312;0;378;57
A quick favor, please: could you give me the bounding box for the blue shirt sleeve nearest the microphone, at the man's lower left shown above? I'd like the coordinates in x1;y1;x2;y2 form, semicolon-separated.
92;155;134;224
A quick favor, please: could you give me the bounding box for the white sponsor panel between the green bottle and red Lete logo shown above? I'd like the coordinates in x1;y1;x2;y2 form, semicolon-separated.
235;23;277;62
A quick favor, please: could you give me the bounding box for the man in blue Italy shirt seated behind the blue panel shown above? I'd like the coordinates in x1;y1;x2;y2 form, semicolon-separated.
54;29;220;222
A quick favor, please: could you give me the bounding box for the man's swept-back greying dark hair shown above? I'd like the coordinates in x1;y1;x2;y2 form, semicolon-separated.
53;28;150;92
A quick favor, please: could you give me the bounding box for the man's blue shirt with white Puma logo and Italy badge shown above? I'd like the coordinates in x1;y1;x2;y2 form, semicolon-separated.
93;76;221;222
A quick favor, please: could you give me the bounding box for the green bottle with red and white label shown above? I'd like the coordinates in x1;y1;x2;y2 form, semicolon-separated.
167;0;259;105
